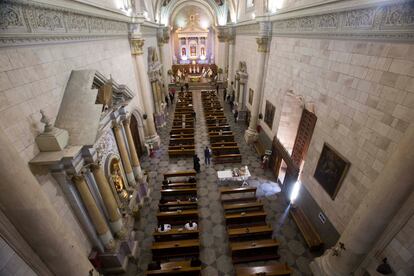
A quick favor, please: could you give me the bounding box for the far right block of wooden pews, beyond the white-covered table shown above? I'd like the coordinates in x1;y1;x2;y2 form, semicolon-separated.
201;91;242;163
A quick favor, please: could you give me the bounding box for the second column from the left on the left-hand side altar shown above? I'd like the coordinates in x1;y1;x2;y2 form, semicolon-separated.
91;164;126;238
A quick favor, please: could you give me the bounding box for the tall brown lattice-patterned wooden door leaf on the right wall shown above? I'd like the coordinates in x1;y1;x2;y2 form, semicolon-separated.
292;109;317;167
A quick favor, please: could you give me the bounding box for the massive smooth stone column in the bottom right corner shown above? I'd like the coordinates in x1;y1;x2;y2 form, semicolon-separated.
311;124;414;276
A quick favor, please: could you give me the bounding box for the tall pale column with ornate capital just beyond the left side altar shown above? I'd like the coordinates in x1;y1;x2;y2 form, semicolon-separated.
131;35;160;148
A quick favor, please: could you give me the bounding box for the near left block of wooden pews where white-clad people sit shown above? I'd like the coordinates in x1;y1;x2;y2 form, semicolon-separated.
146;171;201;276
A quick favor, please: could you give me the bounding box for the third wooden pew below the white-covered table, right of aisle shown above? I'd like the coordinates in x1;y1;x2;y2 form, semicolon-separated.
224;211;266;228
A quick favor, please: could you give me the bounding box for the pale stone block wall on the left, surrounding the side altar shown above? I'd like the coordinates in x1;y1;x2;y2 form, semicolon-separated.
0;37;146;252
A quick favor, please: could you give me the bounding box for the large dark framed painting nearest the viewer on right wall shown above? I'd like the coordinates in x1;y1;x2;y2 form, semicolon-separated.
313;143;350;200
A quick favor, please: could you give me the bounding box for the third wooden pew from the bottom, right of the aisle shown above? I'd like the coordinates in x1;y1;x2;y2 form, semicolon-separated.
227;225;273;241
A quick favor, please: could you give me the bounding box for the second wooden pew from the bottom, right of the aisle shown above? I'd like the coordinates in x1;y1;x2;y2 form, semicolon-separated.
230;239;280;264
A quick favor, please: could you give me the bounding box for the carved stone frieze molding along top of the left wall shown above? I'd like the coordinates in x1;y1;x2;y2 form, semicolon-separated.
0;1;128;47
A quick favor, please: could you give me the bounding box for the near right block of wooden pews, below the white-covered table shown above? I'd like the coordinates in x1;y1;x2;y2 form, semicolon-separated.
220;187;292;276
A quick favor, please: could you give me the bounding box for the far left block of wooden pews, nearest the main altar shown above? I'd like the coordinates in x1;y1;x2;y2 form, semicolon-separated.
168;92;195;157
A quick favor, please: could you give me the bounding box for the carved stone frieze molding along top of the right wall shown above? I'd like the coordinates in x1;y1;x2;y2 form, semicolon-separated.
272;2;414;41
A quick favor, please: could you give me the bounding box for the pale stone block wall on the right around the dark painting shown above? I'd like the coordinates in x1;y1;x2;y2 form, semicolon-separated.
260;37;414;233
